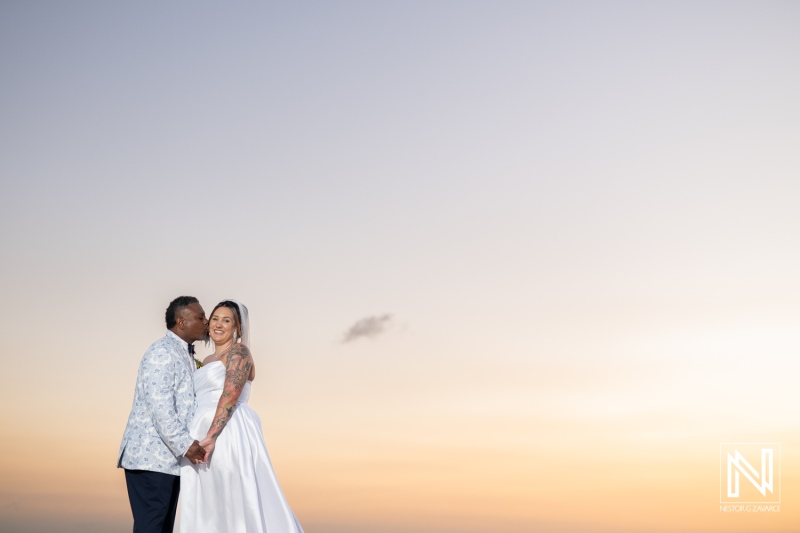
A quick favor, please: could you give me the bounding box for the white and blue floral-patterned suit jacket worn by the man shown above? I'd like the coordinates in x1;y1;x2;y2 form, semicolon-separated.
117;331;196;476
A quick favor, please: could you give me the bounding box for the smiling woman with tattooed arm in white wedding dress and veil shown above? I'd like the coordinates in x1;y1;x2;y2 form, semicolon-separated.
180;300;303;533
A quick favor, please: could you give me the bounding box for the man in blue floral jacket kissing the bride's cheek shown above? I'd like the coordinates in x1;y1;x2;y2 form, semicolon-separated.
117;296;208;533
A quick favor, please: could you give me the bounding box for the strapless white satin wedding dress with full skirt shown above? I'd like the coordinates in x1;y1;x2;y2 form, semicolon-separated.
180;361;303;533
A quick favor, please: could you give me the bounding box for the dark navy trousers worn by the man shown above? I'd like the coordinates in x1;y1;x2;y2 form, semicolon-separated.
125;470;181;533
